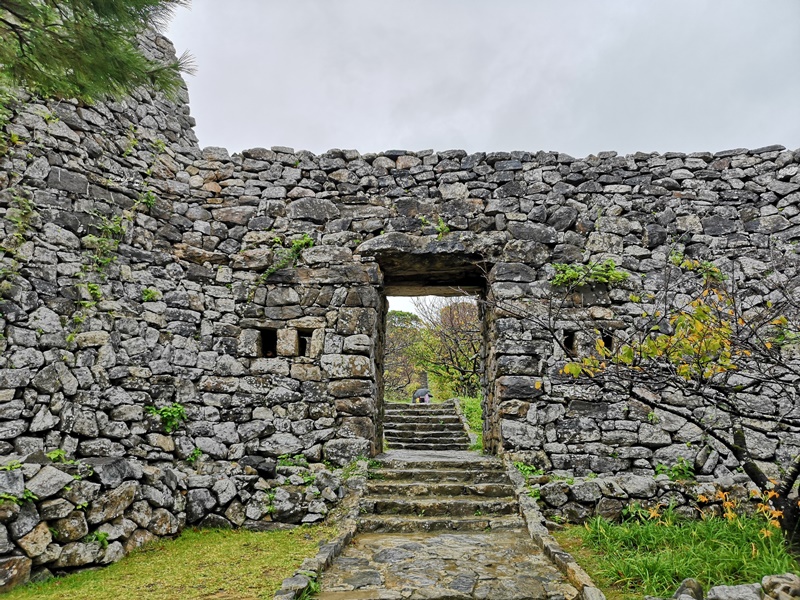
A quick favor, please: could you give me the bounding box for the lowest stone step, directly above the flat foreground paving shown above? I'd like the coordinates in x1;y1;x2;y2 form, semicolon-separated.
358;515;527;535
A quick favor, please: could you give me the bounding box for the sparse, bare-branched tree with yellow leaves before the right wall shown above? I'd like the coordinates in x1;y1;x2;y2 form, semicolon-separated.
498;253;800;544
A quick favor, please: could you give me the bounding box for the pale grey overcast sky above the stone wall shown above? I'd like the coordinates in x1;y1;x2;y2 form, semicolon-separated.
168;0;800;156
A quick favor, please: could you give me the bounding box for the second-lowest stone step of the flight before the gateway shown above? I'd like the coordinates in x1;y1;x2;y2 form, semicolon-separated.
361;496;517;517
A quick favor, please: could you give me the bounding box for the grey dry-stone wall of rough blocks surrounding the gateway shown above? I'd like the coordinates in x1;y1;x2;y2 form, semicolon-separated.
0;29;800;587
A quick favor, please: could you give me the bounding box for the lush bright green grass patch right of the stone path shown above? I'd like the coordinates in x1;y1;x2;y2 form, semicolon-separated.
554;510;800;600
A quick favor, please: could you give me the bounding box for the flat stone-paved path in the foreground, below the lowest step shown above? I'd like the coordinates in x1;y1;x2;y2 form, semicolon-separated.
318;530;578;600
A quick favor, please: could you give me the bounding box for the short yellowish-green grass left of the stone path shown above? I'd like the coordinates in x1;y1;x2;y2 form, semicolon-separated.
3;526;336;600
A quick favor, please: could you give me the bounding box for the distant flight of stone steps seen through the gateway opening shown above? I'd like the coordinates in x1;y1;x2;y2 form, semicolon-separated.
383;402;469;450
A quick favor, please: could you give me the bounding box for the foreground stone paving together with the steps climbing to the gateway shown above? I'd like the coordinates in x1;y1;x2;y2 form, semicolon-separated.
317;440;578;600
